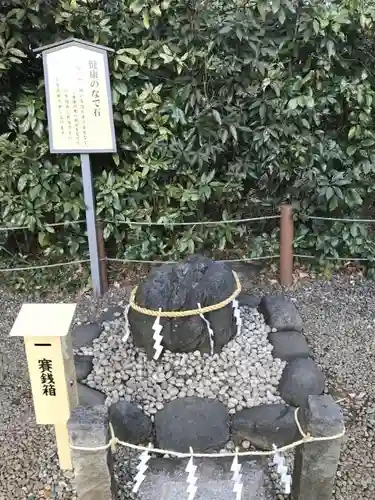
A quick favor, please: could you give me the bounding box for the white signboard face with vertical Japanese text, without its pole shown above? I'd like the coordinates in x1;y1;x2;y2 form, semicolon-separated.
44;46;116;153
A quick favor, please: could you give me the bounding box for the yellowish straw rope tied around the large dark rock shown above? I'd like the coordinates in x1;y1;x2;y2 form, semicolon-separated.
129;271;241;318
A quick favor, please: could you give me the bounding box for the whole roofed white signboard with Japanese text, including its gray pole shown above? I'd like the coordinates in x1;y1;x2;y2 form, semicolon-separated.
34;38;117;296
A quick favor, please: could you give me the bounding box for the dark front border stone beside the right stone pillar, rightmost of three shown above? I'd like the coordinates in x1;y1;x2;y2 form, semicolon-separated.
232;404;299;450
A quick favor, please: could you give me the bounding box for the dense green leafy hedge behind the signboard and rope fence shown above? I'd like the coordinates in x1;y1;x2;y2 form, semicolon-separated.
0;0;375;266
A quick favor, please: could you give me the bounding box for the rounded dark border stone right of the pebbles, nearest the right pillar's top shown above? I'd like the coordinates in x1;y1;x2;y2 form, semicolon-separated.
279;358;325;406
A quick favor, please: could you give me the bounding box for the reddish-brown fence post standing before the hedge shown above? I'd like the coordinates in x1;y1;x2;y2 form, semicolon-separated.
280;204;294;286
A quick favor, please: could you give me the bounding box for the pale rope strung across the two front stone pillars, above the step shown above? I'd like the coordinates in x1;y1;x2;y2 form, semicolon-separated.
70;408;346;458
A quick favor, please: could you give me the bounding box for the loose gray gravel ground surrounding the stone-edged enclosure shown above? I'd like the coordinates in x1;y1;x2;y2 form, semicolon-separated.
0;276;375;500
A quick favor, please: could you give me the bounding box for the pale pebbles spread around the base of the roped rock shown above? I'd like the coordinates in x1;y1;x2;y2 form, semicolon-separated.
81;307;286;415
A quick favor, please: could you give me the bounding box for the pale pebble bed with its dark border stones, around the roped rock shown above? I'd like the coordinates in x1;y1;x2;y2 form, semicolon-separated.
76;286;325;460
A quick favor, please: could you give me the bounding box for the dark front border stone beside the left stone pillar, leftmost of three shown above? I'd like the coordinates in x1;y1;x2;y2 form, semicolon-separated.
109;401;152;444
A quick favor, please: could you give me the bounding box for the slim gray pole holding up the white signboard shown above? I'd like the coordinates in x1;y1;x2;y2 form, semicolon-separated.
81;154;102;297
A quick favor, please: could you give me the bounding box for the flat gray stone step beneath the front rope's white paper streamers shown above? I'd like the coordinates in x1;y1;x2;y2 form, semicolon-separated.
139;458;275;500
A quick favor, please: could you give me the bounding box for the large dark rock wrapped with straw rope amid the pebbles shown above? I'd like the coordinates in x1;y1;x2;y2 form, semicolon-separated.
129;256;236;357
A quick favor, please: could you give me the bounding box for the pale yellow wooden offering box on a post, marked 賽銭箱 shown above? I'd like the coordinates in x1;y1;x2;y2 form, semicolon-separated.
10;304;78;470
